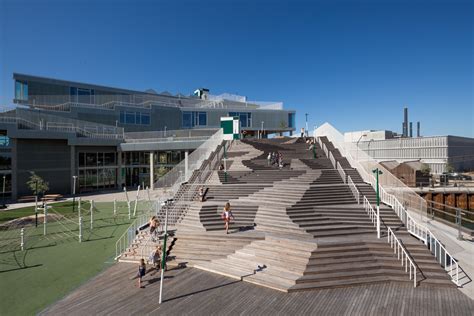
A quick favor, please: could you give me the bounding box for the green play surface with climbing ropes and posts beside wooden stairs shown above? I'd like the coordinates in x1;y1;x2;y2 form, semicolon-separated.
0;202;149;316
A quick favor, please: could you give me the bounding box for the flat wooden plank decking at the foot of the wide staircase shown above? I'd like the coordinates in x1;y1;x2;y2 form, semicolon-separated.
41;263;474;316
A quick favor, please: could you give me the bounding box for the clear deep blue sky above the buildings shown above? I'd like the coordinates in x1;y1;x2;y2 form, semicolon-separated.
0;0;474;137
